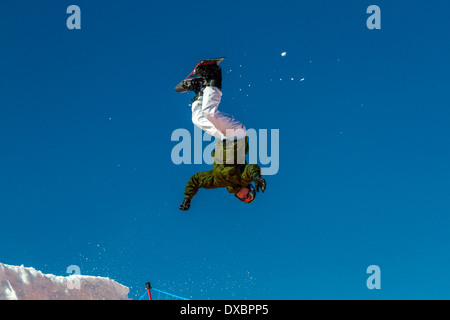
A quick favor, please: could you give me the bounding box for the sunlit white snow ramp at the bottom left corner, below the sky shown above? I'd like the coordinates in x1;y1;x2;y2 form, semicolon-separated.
0;263;130;300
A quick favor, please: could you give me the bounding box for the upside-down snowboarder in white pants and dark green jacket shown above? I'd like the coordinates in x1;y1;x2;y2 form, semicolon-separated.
175;59;266;210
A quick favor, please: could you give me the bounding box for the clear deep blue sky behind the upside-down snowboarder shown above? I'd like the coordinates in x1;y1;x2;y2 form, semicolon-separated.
0;0;450;299
